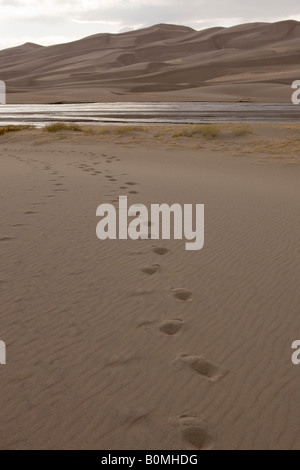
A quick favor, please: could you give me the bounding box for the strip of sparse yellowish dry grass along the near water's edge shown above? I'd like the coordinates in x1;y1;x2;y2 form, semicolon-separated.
0;123;300;164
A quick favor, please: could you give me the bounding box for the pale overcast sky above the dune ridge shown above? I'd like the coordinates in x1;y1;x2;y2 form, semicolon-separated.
0;0;300;49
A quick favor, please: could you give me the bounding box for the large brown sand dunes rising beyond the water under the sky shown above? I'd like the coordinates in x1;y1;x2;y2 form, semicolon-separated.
0;20;300;103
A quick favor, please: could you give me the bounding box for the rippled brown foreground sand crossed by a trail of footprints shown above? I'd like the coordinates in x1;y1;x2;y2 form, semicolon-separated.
0;125;300;449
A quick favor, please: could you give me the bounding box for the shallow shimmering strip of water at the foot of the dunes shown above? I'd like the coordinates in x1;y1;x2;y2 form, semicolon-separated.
0;102;300;126
